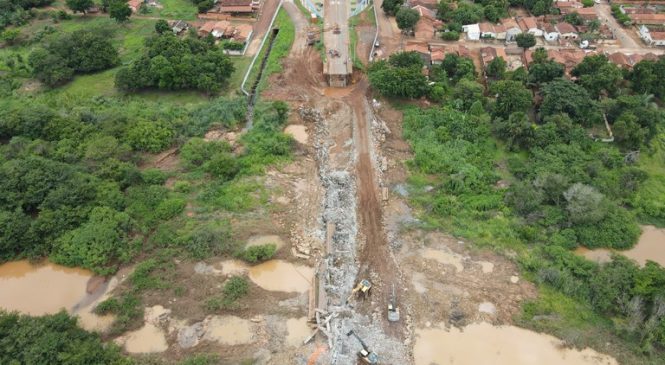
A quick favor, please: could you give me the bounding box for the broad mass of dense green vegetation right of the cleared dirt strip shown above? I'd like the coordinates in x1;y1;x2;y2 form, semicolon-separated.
369;49;665;357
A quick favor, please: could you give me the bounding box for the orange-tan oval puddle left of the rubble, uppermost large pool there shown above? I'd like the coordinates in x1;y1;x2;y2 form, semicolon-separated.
249;260;314;293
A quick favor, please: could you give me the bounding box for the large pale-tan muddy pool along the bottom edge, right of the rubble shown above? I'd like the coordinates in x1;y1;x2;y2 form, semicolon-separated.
414;323;618;365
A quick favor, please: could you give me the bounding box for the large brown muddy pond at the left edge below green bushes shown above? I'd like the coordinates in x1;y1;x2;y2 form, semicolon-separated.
0;260;117;331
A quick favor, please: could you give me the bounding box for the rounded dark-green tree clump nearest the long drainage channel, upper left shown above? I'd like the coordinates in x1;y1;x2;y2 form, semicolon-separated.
115;32;234;93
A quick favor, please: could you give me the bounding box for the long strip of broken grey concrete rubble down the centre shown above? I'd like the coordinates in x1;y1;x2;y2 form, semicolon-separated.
299;107;408;365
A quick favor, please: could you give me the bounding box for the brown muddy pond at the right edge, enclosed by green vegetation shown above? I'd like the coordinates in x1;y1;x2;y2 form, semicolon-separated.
575;226;665;266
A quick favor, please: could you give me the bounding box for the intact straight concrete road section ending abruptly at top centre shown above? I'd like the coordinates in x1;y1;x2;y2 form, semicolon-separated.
323;0;353;87
